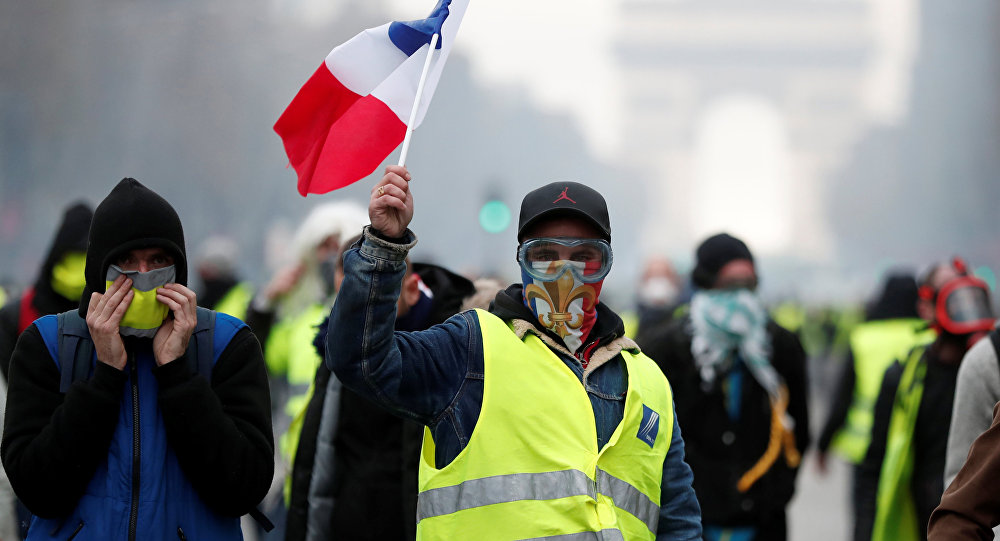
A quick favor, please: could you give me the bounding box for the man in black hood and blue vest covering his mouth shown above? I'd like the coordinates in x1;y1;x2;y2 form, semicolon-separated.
0;178;274;540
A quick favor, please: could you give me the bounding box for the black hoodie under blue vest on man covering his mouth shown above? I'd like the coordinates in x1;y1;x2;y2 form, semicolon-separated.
0;178;274;520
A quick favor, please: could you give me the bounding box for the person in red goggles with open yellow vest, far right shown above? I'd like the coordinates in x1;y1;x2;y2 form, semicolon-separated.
855;258;994;541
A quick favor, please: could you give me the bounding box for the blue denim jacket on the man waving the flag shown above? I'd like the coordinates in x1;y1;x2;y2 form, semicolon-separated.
326;228;702;540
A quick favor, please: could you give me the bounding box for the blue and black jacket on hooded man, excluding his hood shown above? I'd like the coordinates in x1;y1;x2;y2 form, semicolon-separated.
3;314;273;540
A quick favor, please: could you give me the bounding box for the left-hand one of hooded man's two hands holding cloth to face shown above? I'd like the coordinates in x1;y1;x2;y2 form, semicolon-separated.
87;274;135;370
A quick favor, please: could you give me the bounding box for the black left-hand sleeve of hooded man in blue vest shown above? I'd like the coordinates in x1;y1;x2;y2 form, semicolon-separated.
0;325;128;518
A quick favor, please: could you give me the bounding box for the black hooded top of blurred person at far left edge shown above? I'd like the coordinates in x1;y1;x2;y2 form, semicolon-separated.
0;202;94;379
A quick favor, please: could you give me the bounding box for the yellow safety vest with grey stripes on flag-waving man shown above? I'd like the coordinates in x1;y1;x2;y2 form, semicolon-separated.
417;310;673;540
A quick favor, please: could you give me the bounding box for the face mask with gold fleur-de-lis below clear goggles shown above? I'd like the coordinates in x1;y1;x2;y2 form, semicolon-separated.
521;260;604;353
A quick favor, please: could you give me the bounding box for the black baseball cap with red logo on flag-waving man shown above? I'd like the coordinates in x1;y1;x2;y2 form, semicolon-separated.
517;181;611;242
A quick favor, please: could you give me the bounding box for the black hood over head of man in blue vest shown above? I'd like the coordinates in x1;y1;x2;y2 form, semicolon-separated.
80;178;187;317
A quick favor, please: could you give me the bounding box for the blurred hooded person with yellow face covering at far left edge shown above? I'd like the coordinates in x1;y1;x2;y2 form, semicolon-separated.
0;202;94;379
